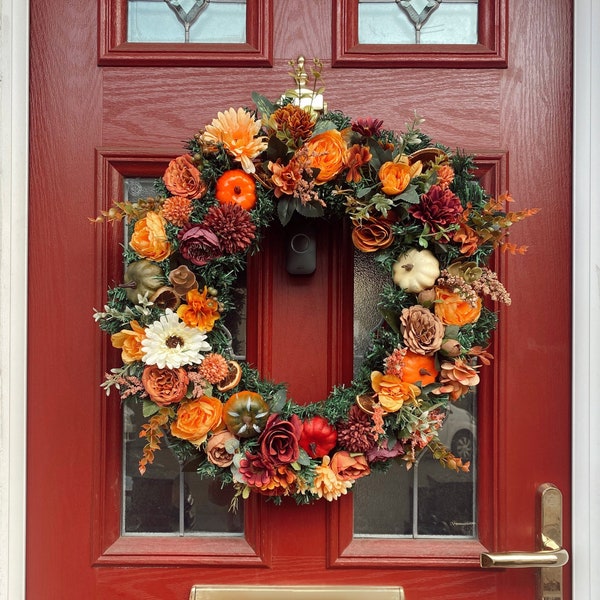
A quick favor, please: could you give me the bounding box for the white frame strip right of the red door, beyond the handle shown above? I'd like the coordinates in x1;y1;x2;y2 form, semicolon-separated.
571;0;600;600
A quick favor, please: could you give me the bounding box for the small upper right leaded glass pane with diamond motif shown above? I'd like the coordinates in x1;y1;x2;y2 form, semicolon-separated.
358;0;478;44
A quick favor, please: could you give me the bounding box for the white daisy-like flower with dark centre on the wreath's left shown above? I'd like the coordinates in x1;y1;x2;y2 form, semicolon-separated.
142;308;211;369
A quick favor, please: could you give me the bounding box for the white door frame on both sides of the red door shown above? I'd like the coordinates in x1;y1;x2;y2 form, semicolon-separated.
0;0;600;600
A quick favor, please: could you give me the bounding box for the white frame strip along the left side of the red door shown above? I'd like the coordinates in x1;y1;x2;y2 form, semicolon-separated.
0;0;29;600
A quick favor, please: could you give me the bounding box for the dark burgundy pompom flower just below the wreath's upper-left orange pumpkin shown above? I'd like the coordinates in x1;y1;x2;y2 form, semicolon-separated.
203;204;256;254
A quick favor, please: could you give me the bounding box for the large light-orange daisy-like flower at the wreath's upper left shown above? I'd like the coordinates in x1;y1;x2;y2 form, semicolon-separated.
201;108;267;173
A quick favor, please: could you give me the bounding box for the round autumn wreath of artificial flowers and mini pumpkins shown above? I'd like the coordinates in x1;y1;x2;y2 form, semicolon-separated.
94;65;535;503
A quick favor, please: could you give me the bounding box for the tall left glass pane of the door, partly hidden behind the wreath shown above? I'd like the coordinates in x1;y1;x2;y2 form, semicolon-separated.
121;178;246;536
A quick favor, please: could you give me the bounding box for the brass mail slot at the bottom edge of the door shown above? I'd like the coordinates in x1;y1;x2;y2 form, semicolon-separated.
190;585;405;600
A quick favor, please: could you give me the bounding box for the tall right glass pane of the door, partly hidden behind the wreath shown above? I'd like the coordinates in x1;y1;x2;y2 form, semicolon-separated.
353;246;477;538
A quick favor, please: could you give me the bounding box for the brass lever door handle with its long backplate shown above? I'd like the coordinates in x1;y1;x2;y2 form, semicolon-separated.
479;483;569;600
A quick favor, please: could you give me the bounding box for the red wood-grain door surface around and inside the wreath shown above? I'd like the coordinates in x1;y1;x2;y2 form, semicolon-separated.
27;0;572;600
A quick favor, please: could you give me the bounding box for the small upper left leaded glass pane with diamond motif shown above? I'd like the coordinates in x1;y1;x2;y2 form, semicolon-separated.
127;0;246;44
